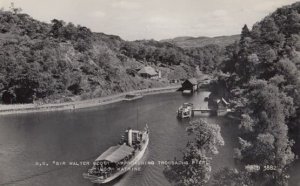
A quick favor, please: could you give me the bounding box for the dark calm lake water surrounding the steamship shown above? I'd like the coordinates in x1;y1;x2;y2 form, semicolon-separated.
0;92;253;186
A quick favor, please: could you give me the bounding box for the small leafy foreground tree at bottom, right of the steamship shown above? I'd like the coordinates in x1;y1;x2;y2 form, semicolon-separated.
164;120;224;186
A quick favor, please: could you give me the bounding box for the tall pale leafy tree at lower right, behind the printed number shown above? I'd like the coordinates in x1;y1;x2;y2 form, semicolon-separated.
232;80;294;185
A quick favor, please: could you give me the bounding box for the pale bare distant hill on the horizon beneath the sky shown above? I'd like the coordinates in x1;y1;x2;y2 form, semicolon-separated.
161;35;240;48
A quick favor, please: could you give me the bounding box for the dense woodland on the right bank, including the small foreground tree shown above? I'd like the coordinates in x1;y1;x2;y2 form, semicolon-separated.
165;3;300;186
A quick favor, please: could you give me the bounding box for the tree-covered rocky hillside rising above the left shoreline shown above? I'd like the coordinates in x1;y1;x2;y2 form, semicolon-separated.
0;11;202;103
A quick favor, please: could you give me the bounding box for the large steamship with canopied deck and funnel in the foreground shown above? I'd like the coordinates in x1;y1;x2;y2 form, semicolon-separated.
83;125;149;184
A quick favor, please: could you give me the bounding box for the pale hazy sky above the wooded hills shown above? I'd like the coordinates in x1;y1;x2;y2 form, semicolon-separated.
0;0;296;40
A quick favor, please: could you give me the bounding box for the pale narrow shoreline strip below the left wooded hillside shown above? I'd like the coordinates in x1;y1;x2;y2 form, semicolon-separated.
0;85;180;115
